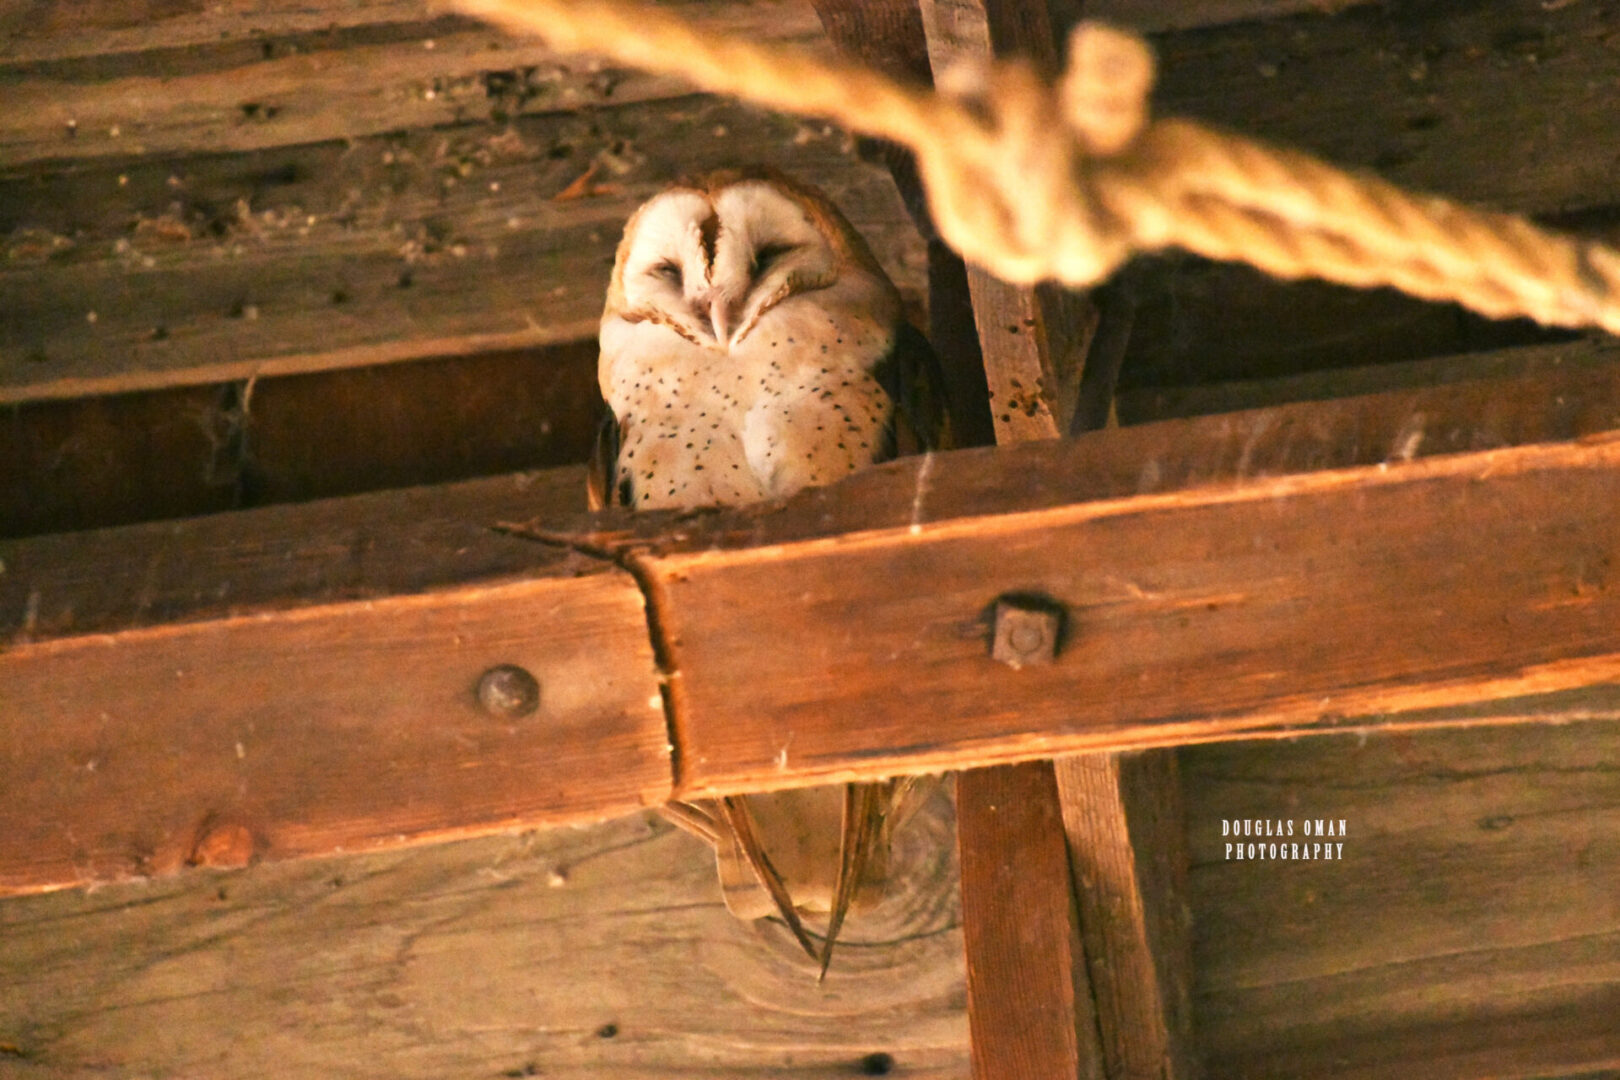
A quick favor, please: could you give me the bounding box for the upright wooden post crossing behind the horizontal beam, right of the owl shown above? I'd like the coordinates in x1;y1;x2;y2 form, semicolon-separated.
920;0;1192;1080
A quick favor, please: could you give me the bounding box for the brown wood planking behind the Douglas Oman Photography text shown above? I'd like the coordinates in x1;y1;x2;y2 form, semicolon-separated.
1178;718;1620;1080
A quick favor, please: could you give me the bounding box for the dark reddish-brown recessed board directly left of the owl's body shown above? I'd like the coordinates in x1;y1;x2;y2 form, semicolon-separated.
0;342;598;536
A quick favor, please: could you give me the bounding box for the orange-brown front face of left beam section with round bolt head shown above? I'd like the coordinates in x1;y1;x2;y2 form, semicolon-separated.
0;575;669;892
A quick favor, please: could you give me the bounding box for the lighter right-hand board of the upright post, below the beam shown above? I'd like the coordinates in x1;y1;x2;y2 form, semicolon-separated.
1053;750;1200;1080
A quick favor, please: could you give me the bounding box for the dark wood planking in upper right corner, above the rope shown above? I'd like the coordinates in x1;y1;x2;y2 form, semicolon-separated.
1153;0;1620;214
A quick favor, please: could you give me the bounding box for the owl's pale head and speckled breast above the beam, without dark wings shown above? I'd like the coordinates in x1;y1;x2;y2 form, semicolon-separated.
598;173;902;510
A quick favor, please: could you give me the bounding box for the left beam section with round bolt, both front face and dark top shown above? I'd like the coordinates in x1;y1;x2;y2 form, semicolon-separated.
0;471;671;892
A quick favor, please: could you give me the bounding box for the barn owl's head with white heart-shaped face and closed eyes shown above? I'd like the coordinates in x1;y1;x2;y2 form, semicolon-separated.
603;168;901;353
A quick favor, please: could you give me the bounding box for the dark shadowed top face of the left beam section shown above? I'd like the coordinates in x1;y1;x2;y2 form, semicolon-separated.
0;466;603;648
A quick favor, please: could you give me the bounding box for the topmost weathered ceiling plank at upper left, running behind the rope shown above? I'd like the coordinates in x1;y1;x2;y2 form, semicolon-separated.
0;0;821;168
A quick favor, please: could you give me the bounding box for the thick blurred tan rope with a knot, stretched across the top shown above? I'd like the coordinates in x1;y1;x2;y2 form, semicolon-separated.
450;0;1620;334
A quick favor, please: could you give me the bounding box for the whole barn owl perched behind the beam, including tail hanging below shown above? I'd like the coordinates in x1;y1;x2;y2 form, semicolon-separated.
590;170;948;975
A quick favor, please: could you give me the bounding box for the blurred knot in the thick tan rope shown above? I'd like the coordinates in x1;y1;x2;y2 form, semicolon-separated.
917;23;1153;285
